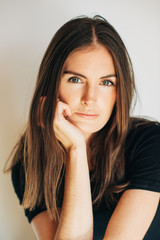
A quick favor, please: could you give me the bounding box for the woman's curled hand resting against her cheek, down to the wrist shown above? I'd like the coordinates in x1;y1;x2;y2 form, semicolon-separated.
53;100;85;150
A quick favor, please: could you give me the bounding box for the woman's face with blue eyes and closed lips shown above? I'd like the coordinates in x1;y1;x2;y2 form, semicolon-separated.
59;44;117;140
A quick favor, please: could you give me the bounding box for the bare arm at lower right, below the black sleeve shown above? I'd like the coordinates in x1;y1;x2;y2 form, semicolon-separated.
104;189;160;240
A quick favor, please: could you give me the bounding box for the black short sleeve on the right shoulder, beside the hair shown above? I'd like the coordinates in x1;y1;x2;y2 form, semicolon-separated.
126;123;160;192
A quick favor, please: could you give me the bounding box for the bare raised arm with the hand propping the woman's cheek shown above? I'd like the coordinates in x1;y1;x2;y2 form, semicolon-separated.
32;101;93;240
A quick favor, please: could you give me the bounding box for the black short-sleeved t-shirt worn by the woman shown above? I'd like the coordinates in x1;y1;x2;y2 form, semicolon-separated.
12;122;160;240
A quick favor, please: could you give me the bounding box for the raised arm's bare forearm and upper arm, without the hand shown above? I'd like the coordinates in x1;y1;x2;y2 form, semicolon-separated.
31;150;93;240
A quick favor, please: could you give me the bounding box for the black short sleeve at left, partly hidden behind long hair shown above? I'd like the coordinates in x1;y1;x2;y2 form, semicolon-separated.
11;162;46;223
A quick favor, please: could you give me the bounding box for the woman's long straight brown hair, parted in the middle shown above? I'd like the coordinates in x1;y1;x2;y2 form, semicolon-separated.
4;16;135;219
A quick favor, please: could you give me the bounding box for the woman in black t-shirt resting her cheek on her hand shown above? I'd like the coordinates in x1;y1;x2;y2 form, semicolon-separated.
5;16;160;240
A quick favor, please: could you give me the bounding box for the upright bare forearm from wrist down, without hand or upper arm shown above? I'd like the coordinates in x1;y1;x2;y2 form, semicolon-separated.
55;145;93;240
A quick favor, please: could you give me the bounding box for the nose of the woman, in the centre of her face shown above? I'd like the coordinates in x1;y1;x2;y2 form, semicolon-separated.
81;85;97;105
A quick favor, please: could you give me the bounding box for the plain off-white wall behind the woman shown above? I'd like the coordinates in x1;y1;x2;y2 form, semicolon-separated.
0;0;160;240
